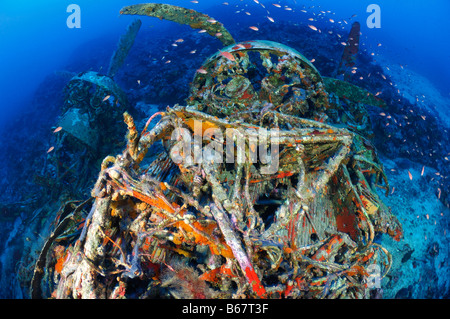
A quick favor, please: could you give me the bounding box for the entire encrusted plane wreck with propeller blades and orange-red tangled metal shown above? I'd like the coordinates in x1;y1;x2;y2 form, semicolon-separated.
30;4;402;298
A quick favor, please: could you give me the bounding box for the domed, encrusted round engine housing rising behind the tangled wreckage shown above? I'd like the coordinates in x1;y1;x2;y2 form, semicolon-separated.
188;40;328;118
